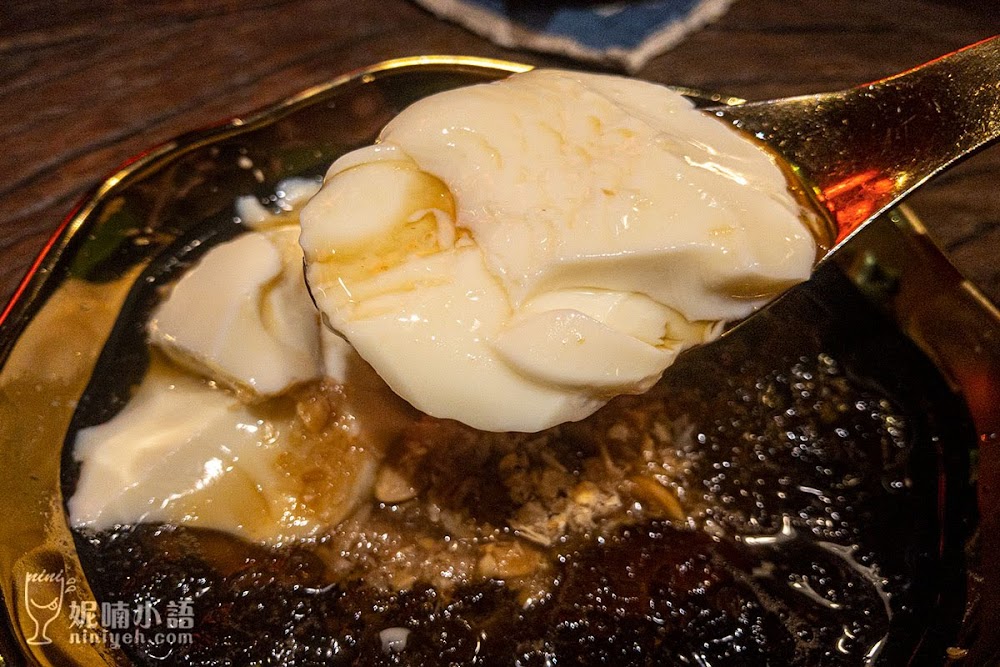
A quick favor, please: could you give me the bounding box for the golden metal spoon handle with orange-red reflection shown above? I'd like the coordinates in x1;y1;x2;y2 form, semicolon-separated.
715;37;1000;246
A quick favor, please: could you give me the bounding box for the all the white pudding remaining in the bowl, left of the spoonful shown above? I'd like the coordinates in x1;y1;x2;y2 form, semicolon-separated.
68;182;414;544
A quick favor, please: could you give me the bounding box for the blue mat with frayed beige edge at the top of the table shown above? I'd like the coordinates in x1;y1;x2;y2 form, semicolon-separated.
416;0;732;70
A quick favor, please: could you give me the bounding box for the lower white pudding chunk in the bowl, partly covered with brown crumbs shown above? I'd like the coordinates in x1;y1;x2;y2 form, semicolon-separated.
68;358;394;545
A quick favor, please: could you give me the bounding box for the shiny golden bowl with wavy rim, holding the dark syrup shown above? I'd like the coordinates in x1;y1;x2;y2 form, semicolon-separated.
0;56;1000;665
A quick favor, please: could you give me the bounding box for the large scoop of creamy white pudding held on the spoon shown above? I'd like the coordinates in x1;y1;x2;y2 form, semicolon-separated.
300;70;816;432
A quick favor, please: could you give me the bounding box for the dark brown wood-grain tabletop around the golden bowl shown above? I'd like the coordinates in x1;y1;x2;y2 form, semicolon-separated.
0;0;1000;305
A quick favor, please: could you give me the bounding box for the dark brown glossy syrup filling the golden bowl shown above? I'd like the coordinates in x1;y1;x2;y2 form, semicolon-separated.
65;244;974;666
